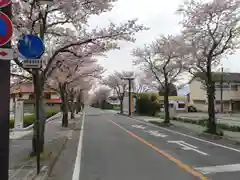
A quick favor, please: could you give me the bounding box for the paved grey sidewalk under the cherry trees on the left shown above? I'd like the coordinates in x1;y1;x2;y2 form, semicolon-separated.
9;115;81;180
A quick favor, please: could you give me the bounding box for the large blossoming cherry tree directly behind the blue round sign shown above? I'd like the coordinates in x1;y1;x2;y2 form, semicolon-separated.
12;0;146;154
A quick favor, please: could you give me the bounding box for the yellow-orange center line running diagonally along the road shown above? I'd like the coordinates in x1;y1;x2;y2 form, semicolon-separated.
109;120;208;180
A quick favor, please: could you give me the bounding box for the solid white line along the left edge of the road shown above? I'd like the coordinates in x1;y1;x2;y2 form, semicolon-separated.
72;112;85;180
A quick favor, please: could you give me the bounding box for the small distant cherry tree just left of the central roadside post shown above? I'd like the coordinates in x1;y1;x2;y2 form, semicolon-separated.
102;71;134;113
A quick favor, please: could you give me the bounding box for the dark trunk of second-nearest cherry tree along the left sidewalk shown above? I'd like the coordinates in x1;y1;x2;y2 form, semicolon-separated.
59;84;68;127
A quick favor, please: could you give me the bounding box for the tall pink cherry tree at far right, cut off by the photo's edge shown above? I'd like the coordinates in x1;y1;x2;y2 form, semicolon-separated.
178;0;240;134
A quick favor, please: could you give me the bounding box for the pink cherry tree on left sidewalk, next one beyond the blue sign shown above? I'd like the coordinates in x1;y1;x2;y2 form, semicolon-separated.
50;55;104;127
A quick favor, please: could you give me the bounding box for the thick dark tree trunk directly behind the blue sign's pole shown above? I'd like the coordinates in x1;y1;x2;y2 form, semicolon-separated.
31;74;46;156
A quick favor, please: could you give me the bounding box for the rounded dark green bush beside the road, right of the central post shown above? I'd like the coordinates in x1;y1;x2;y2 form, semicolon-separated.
136;92;160;116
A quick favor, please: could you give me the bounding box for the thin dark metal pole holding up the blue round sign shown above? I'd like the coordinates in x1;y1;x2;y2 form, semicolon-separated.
33;70;41;174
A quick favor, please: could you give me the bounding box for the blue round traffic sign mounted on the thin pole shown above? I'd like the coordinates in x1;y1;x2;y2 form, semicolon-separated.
18;34;44;59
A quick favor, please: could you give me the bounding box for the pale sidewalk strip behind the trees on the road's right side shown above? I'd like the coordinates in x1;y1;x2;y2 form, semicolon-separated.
136;116;240;142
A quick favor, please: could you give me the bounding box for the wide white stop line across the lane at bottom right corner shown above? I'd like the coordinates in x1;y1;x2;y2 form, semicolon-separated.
194;164;240;174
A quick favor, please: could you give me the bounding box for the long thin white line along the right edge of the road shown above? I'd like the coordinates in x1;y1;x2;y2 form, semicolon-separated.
127;117;240;153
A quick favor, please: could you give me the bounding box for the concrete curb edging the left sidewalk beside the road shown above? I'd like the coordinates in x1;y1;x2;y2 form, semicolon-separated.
33;114;83;180
